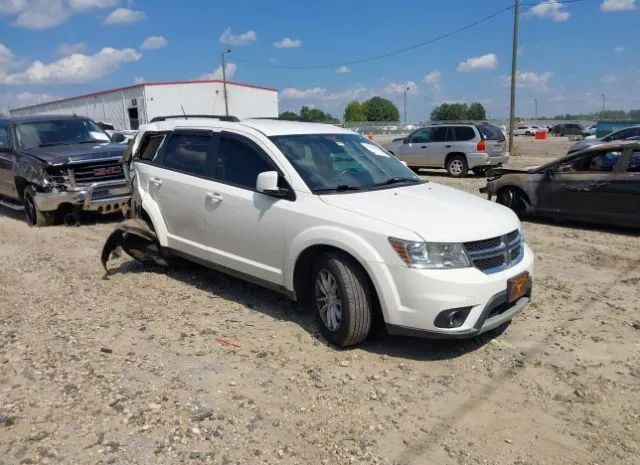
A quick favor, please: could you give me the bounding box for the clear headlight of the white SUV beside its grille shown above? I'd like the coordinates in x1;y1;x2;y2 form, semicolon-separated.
389;237;471;269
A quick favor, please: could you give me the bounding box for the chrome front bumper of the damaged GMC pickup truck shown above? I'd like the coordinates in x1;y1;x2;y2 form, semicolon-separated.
35;179;131;213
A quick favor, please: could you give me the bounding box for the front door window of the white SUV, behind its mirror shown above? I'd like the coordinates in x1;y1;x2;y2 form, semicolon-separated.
215;135;274;189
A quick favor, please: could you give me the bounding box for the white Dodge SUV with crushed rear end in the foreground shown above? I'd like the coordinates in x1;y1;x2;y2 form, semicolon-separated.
116;117;533;346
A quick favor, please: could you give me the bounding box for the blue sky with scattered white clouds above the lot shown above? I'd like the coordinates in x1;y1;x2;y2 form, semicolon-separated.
0;0;640;121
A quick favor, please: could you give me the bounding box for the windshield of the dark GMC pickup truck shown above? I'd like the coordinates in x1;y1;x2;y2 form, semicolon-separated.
16;118;110;149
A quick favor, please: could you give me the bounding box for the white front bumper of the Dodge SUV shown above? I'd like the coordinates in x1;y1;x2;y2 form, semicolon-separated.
376;244;533;338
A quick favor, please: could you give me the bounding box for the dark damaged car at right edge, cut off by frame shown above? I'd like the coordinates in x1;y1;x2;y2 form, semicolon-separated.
480;141;640;228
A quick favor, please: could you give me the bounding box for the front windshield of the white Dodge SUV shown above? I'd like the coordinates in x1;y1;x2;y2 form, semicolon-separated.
271;134;422;192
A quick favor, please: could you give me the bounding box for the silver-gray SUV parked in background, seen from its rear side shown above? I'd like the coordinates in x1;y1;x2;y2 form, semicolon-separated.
385;123;509;178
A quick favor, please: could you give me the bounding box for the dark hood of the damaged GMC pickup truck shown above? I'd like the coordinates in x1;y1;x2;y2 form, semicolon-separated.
22;142;127;165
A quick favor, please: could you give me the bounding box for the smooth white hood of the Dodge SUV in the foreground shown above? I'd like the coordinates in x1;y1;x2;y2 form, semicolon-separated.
320;182;520;242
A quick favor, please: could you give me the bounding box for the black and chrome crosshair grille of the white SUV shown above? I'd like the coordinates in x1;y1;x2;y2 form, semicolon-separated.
463;229;523;273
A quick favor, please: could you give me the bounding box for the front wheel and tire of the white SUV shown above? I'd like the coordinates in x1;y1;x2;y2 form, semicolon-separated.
310;252;372;347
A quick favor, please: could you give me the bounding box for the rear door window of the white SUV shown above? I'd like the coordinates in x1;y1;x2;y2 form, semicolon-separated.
164;134;212;176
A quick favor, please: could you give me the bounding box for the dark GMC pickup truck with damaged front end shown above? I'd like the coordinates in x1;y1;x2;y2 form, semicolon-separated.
0;115;130;226
